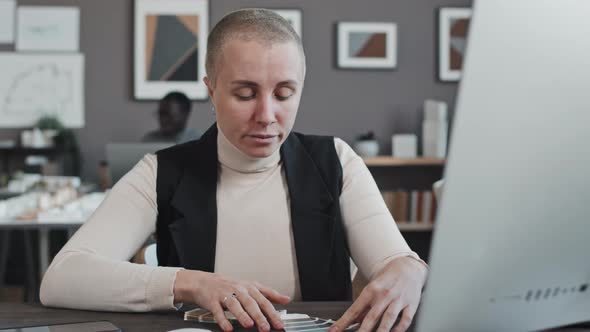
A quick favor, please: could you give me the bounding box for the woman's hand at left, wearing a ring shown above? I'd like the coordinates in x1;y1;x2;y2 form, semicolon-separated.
174;270;291;332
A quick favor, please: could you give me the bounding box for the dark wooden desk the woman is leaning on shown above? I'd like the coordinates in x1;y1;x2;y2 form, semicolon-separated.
0;302;590;332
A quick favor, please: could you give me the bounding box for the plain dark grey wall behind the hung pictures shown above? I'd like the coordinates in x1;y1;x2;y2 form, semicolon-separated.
0;0;471;179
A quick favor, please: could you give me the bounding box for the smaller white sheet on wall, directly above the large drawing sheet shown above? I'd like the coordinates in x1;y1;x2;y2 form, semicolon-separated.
16;6;80;52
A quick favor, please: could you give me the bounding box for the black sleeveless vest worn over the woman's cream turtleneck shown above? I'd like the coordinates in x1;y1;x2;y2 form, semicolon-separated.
156;125;352;301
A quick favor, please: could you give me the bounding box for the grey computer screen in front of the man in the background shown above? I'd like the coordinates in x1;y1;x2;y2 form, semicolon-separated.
106;143;174;183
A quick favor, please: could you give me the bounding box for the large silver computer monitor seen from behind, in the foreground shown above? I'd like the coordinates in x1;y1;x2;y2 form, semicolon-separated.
416;0;590;332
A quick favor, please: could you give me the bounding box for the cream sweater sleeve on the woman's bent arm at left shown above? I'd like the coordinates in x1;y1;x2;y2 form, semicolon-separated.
40;155;179;311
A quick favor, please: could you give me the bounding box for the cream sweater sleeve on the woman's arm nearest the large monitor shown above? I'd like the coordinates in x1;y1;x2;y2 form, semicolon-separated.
334;138;427;280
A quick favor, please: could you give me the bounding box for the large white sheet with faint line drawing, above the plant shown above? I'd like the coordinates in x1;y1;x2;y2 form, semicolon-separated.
0;53;84;128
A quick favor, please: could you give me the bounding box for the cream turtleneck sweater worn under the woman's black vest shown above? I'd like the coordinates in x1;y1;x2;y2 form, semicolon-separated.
40;131;421;311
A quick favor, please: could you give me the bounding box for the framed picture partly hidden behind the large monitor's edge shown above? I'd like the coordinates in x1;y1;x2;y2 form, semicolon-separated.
438;7;472;82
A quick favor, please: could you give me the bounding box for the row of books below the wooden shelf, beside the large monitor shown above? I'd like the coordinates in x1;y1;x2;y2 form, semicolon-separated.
381;190;437;224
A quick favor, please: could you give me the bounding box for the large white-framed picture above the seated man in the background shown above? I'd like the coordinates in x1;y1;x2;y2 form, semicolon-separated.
133;0;209;100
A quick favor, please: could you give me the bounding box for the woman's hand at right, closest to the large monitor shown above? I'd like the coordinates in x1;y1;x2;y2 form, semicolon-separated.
328;257;427;332
